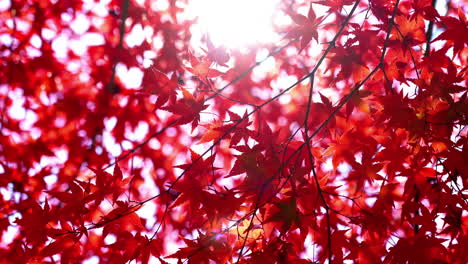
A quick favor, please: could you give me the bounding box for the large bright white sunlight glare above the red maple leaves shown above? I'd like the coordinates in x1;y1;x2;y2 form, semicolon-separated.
190;0;279;48
